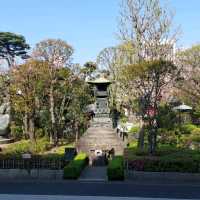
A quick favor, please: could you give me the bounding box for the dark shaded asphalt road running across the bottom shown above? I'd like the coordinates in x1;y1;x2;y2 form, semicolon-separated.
0;180;200;199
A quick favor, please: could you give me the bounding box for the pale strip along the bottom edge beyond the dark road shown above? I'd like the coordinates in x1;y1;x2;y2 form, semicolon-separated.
0;194;192;200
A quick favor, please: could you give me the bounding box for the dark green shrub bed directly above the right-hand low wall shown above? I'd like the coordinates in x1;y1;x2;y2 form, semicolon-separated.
125;145;200;173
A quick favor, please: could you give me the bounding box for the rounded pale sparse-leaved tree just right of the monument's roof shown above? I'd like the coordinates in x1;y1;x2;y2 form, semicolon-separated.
97;43;134;109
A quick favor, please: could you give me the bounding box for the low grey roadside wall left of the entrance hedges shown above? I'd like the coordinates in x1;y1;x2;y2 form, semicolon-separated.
0;169;63;180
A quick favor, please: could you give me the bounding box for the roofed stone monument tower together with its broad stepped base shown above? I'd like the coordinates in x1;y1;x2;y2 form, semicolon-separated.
76;77;124;165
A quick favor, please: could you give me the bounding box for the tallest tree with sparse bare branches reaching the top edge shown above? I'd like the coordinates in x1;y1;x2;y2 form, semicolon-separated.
119;0;180;148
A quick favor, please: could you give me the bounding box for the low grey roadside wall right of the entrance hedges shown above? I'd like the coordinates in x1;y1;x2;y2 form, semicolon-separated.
125;170;200;182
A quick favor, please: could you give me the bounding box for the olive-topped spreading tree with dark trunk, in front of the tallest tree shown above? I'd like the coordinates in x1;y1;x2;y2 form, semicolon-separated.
123;60;178;154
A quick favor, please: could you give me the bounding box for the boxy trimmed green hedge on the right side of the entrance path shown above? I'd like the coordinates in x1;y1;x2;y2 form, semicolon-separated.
107;156;124;181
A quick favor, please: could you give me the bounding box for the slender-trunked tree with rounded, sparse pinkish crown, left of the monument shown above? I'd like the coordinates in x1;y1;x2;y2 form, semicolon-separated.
33;39;73;144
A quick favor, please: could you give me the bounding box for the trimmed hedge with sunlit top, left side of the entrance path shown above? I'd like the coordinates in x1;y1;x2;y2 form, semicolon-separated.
63;153;88;179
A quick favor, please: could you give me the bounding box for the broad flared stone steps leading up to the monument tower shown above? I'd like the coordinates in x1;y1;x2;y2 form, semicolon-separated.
77;117;124;155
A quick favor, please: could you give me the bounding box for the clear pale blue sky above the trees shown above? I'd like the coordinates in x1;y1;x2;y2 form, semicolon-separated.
0;0;200;64
